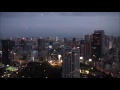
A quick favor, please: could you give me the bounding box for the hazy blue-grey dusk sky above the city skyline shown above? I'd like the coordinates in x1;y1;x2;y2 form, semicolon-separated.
0;12;120;38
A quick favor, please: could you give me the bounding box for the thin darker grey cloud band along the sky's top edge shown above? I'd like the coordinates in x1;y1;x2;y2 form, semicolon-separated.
0;12;120;18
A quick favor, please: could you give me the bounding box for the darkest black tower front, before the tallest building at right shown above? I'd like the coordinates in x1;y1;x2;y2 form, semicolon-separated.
91;34;102;61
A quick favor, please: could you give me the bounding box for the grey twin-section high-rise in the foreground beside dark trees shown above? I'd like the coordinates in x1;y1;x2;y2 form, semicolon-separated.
63;47;80;78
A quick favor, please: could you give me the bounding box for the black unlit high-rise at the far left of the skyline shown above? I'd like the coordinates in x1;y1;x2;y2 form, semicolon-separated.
2;40;14;65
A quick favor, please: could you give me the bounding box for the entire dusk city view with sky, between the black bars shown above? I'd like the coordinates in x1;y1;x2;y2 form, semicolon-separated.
0;12;120;78
